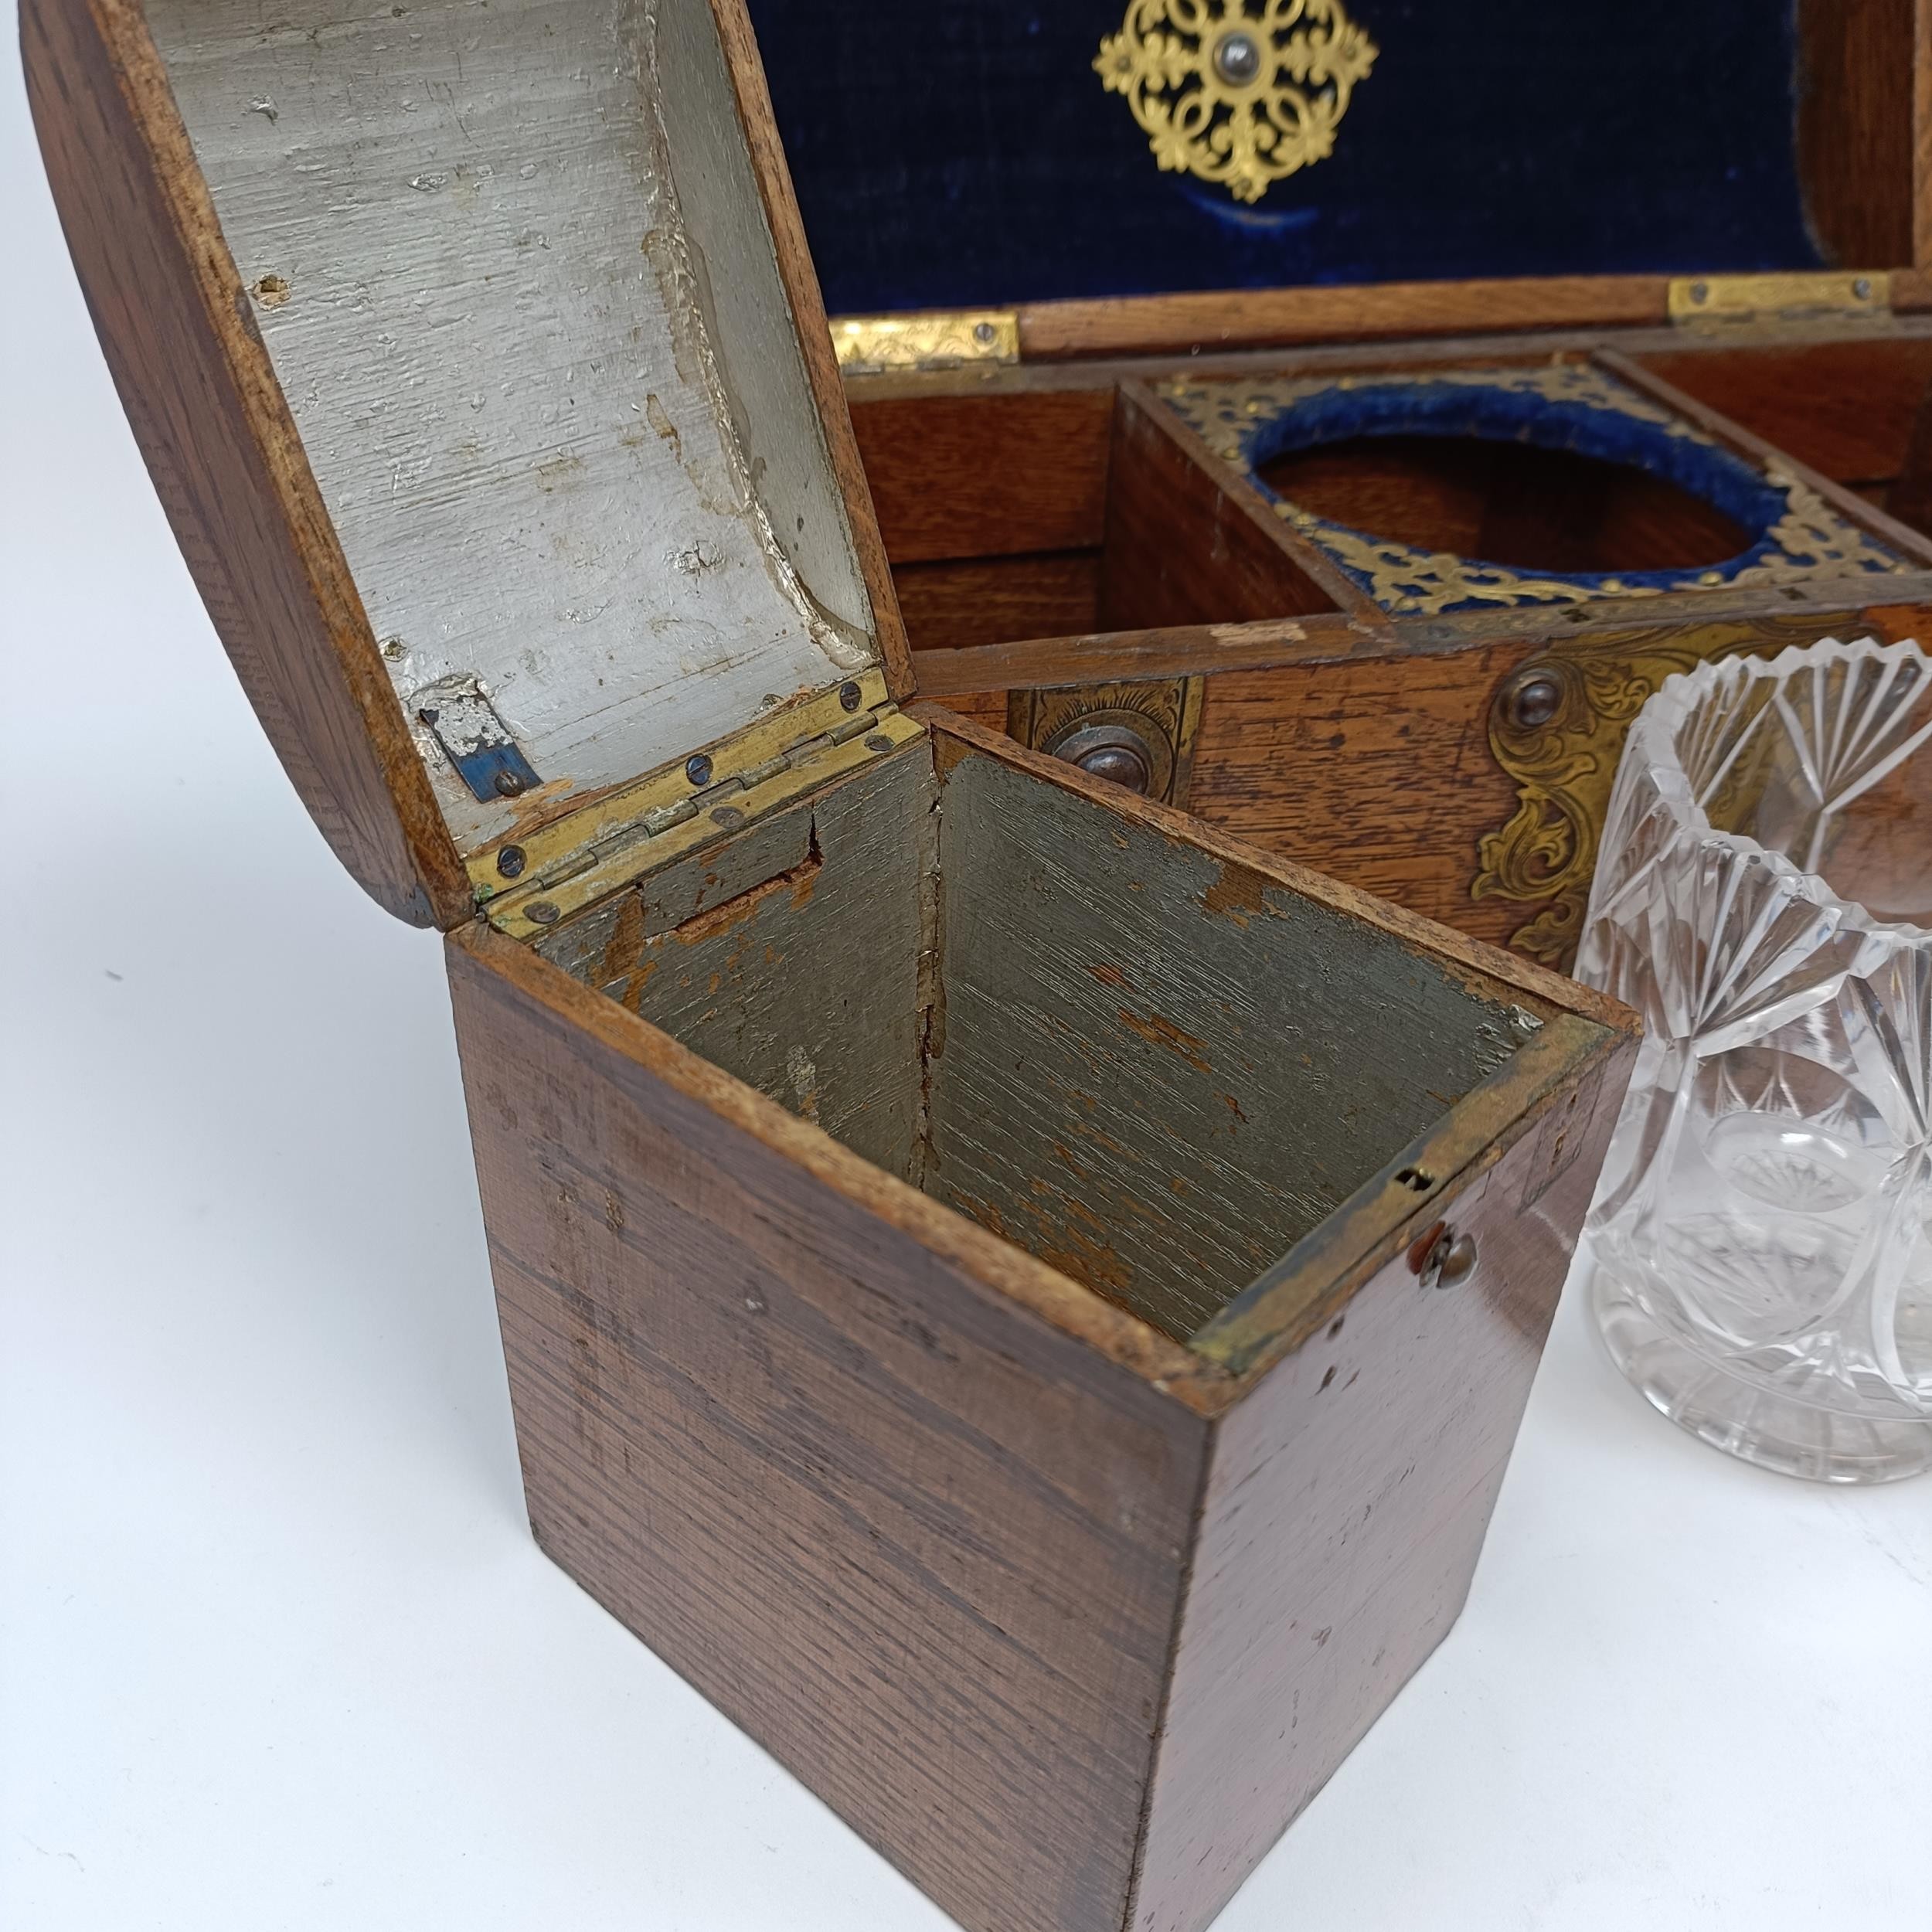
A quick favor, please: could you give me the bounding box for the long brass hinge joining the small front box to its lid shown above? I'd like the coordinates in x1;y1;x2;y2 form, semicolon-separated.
470;671;926;939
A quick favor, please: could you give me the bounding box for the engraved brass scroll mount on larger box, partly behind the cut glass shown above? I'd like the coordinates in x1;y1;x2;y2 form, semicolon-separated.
1468;611;1870;966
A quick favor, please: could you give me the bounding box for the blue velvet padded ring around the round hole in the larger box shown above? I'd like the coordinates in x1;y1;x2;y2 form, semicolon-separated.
1235;377;1889;609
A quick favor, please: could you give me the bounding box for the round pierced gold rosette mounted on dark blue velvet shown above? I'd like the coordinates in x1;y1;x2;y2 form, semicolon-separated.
1094;0;1378;201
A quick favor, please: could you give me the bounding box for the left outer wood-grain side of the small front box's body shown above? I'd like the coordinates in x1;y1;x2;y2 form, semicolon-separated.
451;939;1206;1932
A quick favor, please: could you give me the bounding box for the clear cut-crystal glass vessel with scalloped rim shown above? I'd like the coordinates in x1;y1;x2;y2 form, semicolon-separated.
1577;641;1932;1482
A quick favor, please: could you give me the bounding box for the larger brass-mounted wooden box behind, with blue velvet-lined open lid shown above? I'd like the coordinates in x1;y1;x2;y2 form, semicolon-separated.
769;0;1932;966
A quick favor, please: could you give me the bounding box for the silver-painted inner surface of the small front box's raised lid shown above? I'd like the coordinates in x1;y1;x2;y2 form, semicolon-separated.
147;0;883;854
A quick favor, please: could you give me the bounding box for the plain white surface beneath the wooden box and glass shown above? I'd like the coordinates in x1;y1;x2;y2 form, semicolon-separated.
0;37;1932;1932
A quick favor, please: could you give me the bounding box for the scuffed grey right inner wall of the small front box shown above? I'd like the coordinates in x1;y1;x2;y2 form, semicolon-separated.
926;752;1521;1339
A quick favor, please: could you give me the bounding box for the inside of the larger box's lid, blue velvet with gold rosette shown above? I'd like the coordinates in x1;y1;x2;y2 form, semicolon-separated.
750;0;1915;315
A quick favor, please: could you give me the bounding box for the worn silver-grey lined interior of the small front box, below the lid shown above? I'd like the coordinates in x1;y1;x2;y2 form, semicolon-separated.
539;740;1526;1341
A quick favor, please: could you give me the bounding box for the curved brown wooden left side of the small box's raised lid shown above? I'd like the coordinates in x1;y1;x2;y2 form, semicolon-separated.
22;0;470;926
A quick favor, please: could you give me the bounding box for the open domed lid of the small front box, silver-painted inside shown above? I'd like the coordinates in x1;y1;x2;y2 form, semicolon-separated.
23;0;906;926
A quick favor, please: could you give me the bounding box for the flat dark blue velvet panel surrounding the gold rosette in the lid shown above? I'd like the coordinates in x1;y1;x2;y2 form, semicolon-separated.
750;0;1820;313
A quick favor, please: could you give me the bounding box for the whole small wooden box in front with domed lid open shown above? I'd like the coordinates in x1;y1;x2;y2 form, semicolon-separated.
23;0;1631;1932
